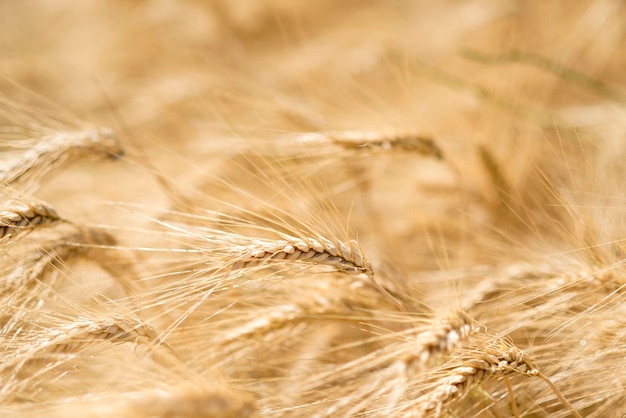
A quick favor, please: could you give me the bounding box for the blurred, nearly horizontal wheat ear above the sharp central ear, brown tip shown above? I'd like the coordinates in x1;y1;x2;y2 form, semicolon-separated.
298;131;443;160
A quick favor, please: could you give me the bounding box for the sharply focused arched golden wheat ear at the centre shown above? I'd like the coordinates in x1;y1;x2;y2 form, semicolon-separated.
233;238;374;277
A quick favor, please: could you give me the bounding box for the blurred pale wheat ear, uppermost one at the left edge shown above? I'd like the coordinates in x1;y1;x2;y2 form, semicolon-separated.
0;129;123;184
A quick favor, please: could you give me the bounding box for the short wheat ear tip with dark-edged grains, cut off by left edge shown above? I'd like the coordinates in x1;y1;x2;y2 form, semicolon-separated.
0;200;61;239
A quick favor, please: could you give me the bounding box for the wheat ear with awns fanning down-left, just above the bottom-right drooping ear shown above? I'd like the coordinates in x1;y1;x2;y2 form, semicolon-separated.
292;312;478;417
